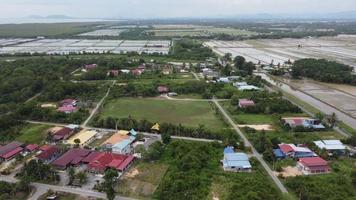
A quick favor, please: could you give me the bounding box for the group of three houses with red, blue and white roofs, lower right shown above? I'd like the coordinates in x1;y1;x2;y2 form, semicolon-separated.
273;140;347;175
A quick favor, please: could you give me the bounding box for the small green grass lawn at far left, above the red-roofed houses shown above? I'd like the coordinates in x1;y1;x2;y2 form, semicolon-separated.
16;124;51;144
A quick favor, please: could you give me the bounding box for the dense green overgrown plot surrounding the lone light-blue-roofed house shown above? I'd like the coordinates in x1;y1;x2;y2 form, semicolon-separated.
134;140;282;200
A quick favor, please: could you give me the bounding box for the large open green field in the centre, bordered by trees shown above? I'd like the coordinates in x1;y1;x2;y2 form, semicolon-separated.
101;98;224;130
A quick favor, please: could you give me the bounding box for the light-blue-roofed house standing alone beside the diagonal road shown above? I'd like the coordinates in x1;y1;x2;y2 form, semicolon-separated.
221;147;252;172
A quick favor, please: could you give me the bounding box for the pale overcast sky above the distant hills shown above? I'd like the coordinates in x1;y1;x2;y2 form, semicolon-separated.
0;0;356;18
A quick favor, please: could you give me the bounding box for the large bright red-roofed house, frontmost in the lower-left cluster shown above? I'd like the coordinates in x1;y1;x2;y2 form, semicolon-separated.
88;152;134;173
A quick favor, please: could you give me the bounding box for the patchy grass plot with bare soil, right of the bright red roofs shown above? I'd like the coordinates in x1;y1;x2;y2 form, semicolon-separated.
118;162;168;199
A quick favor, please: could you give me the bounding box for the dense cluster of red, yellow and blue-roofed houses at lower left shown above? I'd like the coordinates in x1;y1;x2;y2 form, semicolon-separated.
0;125;137;177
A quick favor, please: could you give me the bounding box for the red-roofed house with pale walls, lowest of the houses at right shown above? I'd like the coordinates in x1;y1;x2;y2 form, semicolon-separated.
297;157;331;175
